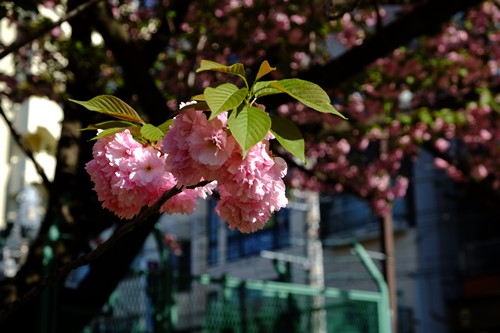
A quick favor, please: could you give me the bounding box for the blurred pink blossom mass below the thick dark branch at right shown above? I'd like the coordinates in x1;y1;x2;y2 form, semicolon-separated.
284;1;500;215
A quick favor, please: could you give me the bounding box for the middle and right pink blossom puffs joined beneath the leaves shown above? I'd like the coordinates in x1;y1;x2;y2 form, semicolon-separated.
163;109;288;232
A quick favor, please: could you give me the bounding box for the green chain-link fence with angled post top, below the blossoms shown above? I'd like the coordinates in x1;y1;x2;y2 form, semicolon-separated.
85;243;390;333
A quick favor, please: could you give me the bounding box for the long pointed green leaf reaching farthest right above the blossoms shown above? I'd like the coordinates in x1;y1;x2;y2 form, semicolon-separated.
269;79;346;119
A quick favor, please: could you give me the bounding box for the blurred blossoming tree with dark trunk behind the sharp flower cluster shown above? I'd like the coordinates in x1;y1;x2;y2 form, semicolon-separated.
0;0;500;332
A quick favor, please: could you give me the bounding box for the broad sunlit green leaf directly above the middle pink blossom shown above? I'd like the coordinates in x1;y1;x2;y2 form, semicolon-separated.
204;83;248;120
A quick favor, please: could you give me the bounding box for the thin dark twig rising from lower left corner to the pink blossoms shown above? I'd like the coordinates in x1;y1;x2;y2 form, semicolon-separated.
0;181;210;322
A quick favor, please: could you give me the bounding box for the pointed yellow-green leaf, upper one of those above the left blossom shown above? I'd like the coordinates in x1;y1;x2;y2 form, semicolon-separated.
69;95;144;124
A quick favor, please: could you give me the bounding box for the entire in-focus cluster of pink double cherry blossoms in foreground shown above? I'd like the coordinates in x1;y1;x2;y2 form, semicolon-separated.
86;109;288;232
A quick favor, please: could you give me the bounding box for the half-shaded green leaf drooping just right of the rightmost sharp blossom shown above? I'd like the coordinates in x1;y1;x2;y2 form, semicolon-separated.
271;115;306;164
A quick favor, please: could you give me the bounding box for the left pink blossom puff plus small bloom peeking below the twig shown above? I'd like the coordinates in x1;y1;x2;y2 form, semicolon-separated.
86;130;213;219
